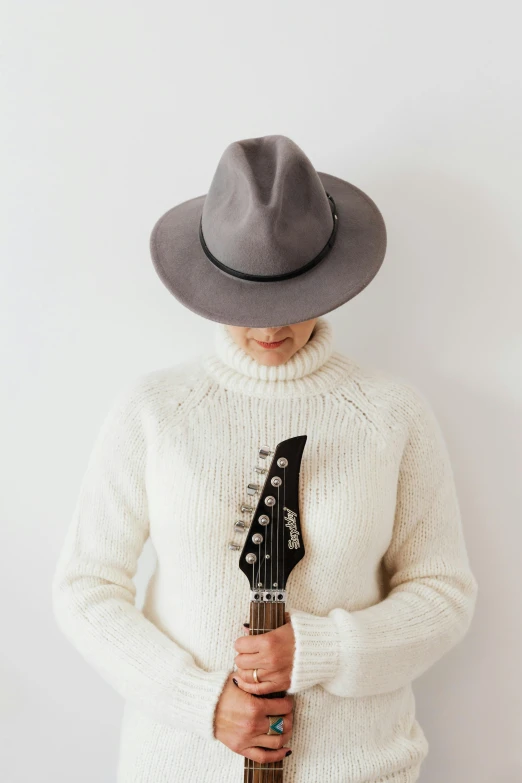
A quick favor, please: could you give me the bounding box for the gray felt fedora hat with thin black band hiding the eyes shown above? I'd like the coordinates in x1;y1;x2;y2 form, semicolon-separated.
150;135;386;327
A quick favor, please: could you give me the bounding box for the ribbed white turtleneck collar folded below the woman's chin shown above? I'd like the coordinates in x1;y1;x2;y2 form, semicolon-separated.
202;316;350;397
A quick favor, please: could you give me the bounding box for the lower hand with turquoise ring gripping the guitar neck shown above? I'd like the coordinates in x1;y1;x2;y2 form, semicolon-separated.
214;672;293;763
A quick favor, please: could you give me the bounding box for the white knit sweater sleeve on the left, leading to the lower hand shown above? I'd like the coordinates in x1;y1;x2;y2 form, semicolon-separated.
52;383;228;741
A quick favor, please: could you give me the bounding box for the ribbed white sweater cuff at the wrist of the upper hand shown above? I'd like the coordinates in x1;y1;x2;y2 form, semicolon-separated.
287;609;341;693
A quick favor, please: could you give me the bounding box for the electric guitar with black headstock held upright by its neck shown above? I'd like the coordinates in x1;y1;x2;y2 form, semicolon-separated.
229;435;307;783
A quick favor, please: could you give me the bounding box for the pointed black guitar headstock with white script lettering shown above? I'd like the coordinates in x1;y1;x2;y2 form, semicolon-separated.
239;435;307;600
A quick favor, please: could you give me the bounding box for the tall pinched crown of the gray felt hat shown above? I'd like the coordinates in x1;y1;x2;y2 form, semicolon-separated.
201;135;333;276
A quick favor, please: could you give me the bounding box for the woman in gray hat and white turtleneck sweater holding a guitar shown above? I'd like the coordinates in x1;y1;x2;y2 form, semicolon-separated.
53;136;477;783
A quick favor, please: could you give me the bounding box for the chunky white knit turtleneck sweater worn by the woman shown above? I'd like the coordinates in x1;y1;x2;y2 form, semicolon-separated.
53;316;478;783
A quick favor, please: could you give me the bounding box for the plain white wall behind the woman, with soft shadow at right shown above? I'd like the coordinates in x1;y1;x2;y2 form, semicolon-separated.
0;0;522;783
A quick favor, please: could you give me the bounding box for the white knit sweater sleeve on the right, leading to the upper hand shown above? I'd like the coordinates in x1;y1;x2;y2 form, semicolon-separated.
288;387;478;697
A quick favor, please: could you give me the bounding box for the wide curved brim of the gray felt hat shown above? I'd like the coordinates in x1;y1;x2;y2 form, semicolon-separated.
150;171;387;327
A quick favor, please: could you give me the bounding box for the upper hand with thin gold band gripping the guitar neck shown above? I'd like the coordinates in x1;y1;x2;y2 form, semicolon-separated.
234;612;295;696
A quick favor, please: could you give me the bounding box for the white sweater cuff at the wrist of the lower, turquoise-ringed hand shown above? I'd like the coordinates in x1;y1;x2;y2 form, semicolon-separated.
165;666;231;741
